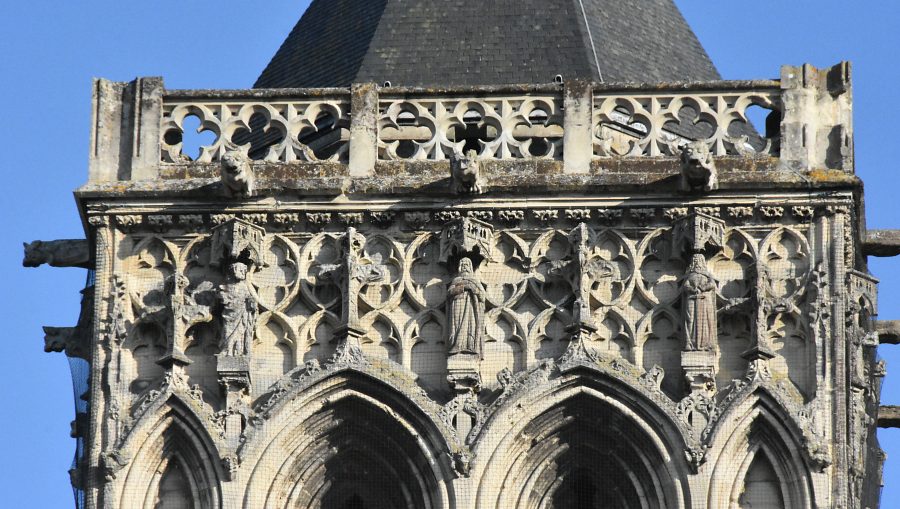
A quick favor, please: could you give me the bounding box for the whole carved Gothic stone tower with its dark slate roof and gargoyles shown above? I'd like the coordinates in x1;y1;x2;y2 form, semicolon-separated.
25;0;900;509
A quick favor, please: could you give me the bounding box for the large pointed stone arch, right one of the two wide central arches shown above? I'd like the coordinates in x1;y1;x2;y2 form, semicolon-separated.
472;369;690;509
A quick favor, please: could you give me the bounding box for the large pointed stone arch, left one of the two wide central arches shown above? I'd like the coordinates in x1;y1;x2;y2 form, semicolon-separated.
240;368;454;509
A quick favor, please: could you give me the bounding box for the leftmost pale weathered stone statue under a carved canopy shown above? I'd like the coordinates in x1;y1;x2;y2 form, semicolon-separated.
219;262;257;356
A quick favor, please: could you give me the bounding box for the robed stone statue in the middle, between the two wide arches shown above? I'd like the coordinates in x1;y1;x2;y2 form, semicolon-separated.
447;258;485;355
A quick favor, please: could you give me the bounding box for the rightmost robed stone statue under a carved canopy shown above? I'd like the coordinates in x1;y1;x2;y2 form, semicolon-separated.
681;254;718;351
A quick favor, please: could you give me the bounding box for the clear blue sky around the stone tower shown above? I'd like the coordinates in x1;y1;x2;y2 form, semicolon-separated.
0;0;900;508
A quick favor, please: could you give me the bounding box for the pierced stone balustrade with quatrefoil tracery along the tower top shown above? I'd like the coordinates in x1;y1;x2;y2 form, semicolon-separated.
91;64;852;182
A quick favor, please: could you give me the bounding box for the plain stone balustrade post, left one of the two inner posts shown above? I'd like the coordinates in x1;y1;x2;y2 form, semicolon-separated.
350;83;378;177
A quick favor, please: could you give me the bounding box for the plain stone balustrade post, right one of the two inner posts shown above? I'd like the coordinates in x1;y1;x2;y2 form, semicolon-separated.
563;80;594;173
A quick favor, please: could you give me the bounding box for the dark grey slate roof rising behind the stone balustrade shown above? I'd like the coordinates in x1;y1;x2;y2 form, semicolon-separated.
254;0;720;88
